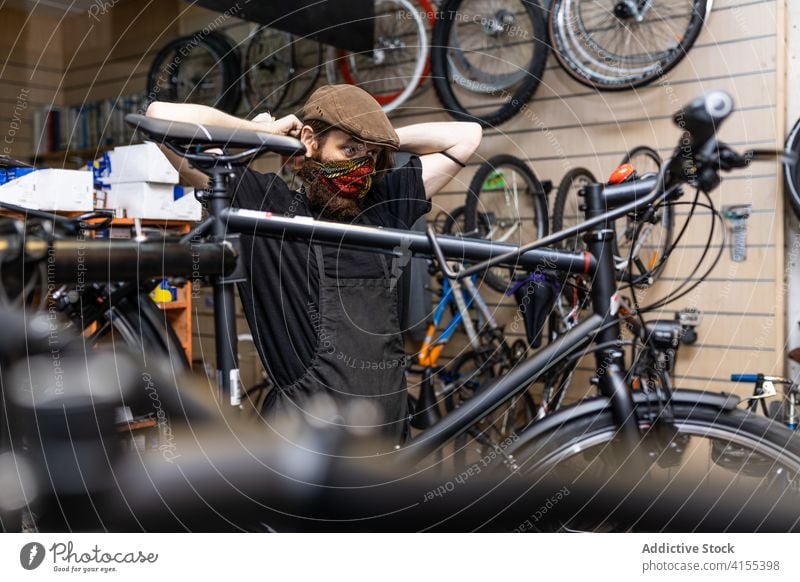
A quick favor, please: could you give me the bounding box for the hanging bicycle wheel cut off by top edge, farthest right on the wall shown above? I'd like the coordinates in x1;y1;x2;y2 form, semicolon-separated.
549;0;708;91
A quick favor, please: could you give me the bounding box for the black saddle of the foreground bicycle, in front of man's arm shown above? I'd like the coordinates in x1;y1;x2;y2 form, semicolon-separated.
125;113;306;156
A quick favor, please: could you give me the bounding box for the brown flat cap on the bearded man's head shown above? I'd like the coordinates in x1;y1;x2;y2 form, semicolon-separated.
302;85;400;150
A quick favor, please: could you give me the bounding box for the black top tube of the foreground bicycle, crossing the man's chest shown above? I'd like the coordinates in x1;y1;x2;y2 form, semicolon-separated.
219;208;597;275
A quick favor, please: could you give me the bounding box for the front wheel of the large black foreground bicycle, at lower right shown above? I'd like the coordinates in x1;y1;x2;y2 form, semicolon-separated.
494;391;800;531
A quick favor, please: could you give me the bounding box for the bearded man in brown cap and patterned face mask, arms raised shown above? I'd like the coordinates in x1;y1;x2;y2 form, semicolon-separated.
147;85;481;442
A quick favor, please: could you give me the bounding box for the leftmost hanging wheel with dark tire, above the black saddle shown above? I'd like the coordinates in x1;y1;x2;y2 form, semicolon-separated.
147;32;241;113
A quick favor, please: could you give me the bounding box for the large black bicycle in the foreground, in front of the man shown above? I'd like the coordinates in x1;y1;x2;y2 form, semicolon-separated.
115;92;800;532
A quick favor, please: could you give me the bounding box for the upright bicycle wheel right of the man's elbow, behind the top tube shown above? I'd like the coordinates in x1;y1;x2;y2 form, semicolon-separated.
464;154;549;293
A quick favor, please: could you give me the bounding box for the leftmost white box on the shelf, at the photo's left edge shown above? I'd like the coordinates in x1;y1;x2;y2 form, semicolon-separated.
0;169;94;211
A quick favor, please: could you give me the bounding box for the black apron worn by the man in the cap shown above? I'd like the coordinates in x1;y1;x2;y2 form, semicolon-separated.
264;245;408;444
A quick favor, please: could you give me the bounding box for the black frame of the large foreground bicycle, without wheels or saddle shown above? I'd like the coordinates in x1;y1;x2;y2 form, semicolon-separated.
197;178;657;461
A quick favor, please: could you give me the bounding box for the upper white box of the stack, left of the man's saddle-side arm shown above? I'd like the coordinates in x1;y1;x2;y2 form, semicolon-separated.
100;142;178;184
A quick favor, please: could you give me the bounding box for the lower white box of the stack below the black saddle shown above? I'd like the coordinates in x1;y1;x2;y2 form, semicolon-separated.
106;182;202;221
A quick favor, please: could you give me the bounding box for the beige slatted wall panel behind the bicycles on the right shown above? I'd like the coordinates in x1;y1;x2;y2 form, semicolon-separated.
394;0;785;402
